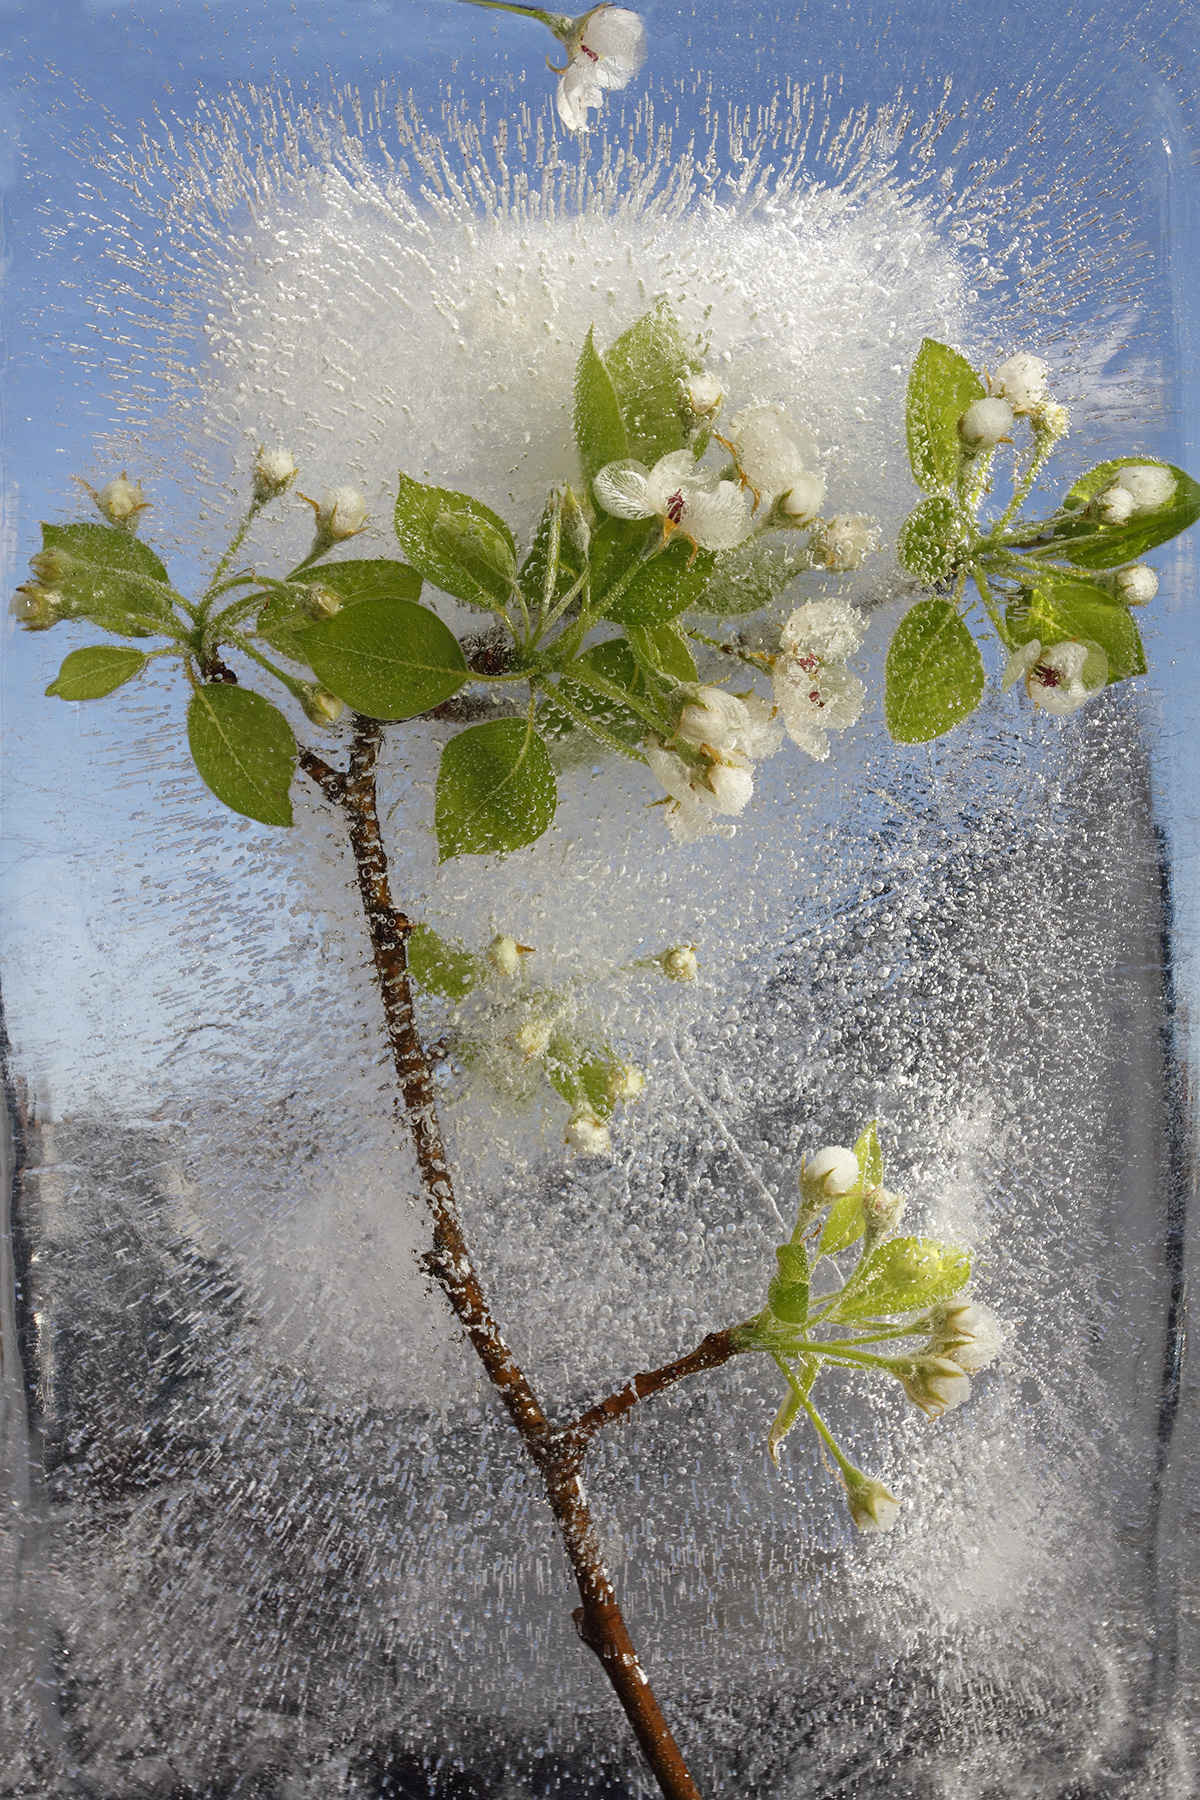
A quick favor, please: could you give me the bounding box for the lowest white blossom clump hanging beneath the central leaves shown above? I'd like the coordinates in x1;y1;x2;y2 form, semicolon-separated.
642;686;783;844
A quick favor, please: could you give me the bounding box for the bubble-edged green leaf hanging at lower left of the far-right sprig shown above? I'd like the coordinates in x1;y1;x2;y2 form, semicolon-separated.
883;599;984;743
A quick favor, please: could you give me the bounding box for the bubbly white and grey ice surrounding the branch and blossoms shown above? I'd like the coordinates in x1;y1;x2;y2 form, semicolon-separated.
0;66;1193;1800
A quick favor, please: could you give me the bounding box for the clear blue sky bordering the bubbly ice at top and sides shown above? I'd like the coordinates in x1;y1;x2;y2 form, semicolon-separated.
0;0;1200;1101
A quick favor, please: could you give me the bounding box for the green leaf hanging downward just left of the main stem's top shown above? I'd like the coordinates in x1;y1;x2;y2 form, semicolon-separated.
187;682;295;824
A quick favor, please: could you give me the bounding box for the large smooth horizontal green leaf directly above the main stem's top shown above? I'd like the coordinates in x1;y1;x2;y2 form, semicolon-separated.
302;599;470;718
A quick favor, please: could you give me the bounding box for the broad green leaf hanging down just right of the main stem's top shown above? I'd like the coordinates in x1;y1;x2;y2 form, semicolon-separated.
435;718;558;862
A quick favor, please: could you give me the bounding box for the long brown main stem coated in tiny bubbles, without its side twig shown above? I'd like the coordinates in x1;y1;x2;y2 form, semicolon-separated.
300;720;708;1800
